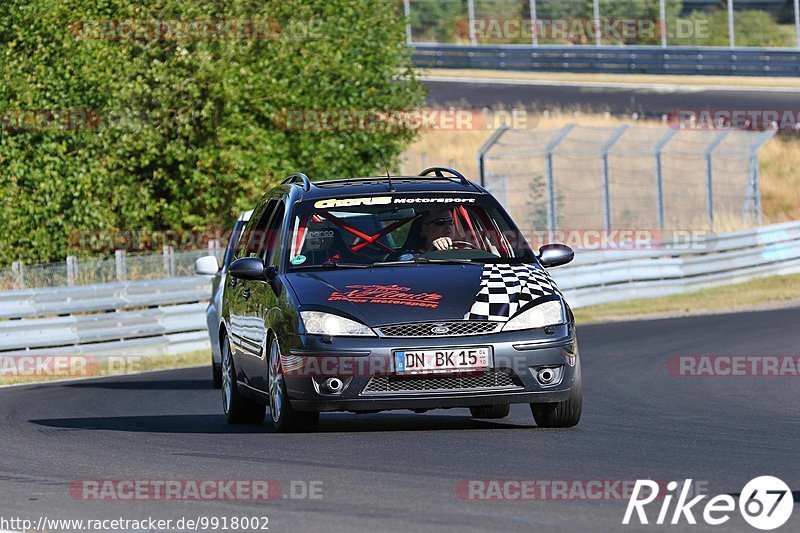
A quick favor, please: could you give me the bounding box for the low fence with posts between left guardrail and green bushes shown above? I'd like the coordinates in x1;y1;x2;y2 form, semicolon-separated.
0;246;225;290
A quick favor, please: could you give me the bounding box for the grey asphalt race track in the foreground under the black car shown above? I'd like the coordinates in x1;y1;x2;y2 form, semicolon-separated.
0;309;800;532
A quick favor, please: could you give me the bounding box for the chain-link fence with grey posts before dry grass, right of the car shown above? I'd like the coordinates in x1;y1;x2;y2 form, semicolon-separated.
478;124;774;230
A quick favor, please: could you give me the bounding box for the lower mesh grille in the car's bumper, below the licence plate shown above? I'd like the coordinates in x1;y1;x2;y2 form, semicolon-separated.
361;370;523;395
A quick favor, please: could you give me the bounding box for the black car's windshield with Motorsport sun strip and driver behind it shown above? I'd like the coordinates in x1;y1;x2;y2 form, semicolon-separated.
288;193;536;269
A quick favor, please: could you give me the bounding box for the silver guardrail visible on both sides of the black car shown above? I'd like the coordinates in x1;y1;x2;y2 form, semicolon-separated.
0;222;800;355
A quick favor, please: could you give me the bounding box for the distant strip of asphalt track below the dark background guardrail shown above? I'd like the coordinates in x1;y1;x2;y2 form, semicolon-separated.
425;80;798;116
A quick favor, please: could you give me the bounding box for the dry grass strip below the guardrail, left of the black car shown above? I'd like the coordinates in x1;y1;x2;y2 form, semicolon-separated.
0;350;211;387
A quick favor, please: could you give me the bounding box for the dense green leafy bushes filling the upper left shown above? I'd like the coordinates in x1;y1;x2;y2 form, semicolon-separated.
0;0;423;265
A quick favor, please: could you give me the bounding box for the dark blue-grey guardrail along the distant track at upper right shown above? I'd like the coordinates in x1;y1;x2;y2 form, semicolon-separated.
412;43;800;77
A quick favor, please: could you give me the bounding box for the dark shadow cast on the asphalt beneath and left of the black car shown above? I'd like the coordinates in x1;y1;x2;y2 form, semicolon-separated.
30;413;532;434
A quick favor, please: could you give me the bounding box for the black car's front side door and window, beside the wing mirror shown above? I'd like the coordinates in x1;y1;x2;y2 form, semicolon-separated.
246;198;286;390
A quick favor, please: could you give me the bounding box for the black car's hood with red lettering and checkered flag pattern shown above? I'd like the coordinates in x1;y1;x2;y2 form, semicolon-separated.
286;263;561;326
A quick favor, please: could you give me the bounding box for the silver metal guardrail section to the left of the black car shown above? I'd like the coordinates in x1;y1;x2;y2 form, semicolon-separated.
0;276;211;355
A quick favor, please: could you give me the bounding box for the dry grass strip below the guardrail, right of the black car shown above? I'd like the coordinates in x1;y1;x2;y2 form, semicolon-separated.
574;274;800;324
